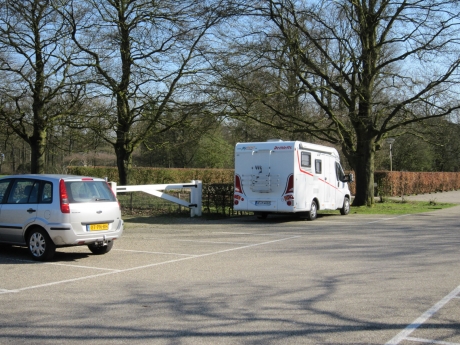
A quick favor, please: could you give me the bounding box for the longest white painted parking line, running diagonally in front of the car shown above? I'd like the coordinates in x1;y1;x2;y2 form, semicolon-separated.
1;236;301;294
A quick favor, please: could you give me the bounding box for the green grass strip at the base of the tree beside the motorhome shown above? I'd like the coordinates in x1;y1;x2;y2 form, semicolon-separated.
318;200;457;214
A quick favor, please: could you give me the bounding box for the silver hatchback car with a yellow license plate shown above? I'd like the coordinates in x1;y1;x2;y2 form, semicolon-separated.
0;174;123;261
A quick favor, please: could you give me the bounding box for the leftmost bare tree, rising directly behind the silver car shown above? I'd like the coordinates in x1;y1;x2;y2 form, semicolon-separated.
0;0;81;173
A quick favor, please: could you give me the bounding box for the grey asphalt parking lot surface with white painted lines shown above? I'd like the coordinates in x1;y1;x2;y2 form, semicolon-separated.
0;194;460;345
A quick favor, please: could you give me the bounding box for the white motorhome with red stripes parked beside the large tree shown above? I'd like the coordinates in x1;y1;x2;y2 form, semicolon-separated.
233;140;353;220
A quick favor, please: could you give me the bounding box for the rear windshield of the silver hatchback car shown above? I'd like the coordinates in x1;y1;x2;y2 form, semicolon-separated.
65;181;116;203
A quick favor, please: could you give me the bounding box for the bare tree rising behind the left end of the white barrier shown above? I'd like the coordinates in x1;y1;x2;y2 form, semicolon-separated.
65;0;246;184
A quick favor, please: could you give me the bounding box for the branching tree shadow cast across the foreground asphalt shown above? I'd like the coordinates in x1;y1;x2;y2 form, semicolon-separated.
0;276;459;345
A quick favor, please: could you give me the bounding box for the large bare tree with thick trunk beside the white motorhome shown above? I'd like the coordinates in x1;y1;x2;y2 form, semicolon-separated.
218;0;460;206
